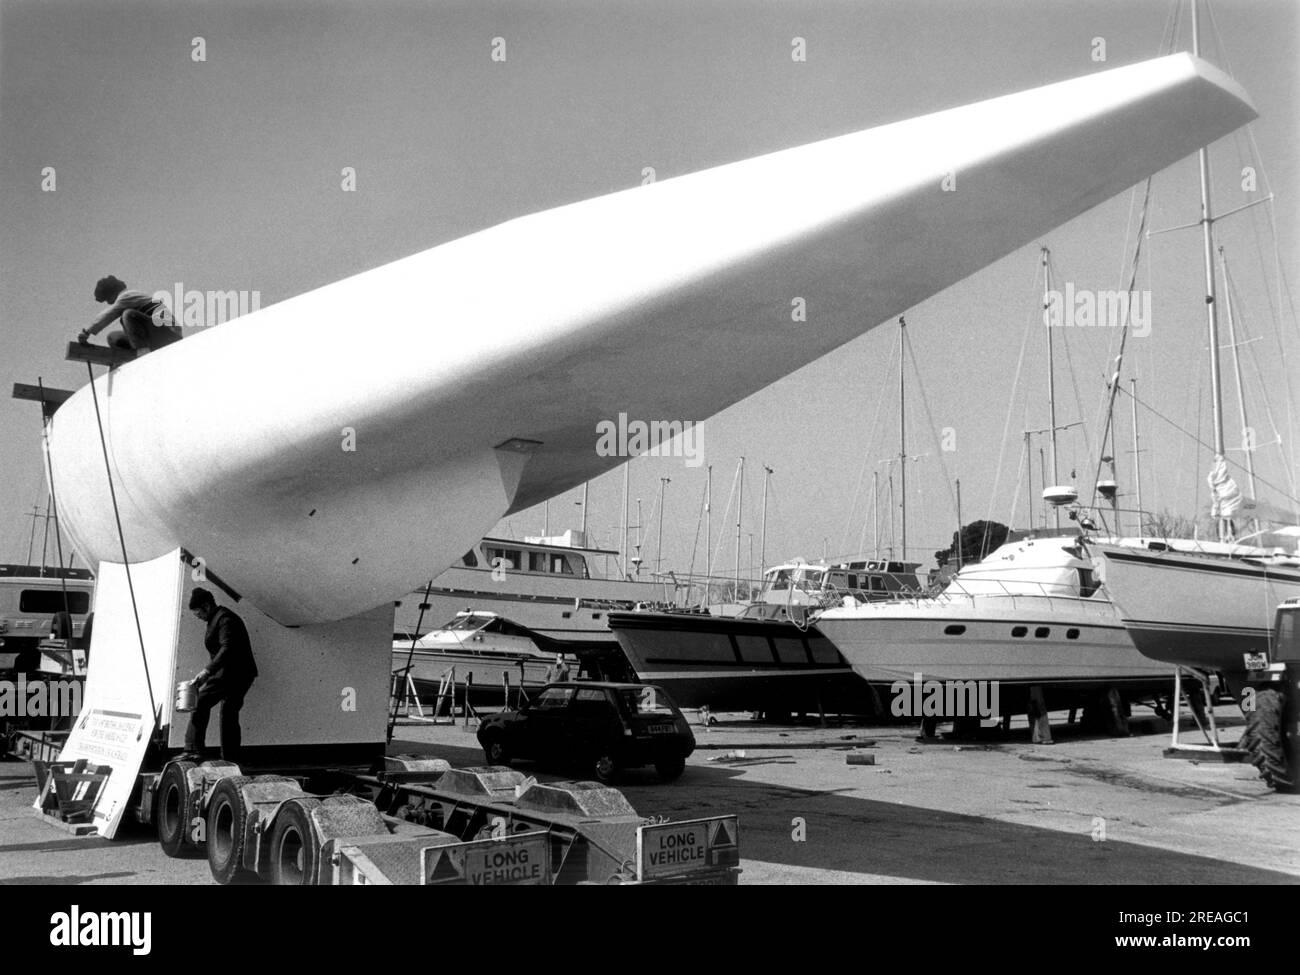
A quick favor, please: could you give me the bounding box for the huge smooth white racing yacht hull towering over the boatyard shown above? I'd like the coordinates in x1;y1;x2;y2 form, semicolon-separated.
49;55;1256;625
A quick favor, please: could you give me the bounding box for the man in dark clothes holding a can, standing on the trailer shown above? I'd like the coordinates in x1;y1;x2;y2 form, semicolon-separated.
183;589;257;762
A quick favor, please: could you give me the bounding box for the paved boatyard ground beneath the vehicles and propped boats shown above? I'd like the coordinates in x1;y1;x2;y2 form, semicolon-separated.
0;706;1300;884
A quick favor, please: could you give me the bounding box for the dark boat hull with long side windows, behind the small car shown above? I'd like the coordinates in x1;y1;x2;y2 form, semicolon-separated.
610;612;878;714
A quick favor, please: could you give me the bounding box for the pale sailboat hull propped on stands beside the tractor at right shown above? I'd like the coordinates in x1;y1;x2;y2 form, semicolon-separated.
1088;542;1300;673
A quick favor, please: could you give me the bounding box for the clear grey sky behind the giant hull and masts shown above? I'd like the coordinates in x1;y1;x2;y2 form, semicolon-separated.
0;0;1300;579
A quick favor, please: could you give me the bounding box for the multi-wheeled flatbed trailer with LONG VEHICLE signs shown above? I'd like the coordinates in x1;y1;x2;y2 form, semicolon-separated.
135;758;740;885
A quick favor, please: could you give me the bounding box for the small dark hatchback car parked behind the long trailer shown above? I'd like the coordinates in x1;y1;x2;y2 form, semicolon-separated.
478;680;696;784
